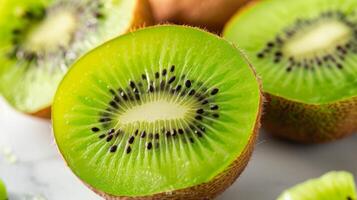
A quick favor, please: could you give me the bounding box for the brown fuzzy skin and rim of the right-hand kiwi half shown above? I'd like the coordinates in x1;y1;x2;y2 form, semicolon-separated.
223;0;357;144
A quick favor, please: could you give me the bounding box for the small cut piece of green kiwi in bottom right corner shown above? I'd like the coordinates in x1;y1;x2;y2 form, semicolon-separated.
278;172;357;200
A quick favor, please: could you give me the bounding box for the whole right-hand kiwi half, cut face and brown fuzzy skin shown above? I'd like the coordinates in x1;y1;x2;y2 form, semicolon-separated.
224;0;357;143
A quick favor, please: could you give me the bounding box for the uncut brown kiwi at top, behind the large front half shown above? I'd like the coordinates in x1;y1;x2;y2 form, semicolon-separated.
150;0;249;33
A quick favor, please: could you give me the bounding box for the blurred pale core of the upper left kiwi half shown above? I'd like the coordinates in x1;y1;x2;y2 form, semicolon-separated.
24;10;77;53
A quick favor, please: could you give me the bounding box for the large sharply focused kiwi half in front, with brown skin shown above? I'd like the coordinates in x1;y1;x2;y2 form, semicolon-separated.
52;25;261;200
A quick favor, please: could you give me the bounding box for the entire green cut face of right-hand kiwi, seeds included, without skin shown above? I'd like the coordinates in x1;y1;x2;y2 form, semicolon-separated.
224;0;357;104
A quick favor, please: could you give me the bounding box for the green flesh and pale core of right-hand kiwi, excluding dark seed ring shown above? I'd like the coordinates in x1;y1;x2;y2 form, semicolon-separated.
224;0;357;104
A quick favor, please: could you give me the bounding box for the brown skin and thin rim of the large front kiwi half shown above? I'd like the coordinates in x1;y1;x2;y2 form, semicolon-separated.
52;25;262;200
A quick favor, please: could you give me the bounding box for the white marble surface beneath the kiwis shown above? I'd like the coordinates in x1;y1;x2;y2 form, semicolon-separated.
0;96;357;200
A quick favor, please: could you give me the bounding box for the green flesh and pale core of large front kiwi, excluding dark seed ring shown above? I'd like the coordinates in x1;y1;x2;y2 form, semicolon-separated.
52;26;260;196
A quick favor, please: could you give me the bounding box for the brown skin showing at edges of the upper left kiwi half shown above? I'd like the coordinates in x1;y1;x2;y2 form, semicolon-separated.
28;0;154;119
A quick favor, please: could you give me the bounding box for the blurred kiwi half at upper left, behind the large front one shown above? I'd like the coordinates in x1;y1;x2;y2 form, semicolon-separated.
0;0;151;117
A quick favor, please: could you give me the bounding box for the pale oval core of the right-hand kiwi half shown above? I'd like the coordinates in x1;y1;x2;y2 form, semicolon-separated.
283;21;352;58
